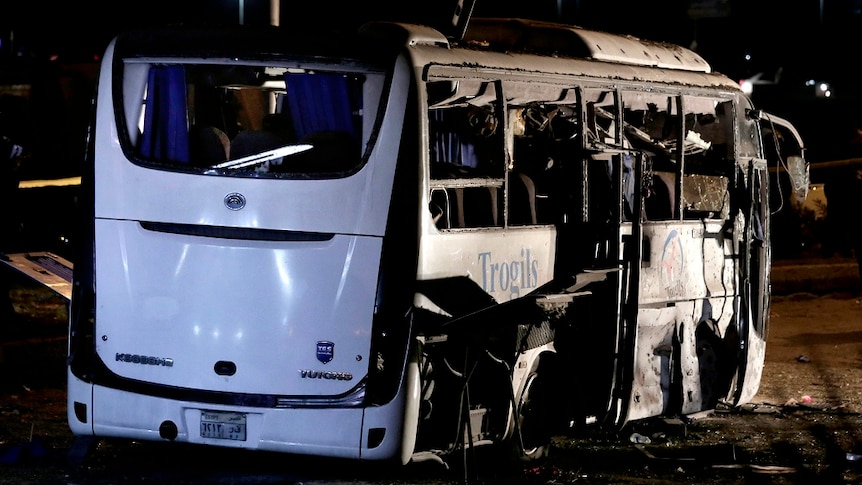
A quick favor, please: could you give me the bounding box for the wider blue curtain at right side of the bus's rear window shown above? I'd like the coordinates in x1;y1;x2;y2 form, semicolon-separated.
284;74;360;140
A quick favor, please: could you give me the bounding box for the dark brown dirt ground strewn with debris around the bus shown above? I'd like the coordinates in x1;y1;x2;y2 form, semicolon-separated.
0;278;862;484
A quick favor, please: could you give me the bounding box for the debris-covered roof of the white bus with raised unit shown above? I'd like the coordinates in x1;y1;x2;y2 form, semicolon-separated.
106;18;728;91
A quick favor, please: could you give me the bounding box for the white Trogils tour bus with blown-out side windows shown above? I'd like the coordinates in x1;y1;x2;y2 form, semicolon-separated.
60;18;806;464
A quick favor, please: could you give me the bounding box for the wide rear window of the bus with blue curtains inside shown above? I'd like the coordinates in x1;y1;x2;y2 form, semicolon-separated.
122;63;380;178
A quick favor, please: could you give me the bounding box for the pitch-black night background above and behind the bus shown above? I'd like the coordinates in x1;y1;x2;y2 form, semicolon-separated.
0;0;862;178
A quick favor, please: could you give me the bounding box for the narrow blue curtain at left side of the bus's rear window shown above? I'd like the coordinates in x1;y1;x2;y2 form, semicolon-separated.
139;66;189;163
